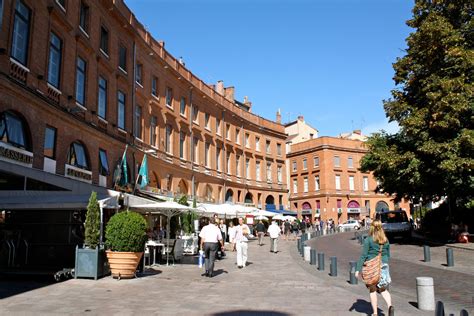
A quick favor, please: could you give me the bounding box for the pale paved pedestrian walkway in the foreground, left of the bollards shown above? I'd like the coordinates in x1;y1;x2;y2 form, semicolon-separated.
0;238;433;315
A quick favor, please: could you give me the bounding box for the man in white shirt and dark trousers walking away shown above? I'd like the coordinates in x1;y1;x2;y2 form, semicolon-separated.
199;218;224;278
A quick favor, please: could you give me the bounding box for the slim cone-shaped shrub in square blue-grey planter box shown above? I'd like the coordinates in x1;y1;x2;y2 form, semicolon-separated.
74;192;109;280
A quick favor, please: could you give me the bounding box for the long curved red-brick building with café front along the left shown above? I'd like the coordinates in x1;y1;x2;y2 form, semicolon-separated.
0;0;288;267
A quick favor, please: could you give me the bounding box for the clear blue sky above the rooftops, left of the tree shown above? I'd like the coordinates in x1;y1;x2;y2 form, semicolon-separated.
125;0;413;136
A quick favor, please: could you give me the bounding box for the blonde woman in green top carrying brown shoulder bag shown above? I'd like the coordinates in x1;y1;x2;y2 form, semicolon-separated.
355;219;395;316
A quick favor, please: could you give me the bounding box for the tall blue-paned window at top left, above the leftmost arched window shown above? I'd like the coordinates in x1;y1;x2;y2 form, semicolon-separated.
11;0;31;66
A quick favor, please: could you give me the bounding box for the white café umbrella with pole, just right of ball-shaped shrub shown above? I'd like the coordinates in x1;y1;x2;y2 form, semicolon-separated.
129;201;196;265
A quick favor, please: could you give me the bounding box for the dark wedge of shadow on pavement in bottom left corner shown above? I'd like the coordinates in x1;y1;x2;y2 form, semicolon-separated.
0;275;56;300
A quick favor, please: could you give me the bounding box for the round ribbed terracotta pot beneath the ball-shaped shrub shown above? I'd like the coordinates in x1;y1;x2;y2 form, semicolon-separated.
107;250;143;279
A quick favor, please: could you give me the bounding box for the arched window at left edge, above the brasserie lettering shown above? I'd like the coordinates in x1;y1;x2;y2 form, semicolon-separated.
0;111;31;151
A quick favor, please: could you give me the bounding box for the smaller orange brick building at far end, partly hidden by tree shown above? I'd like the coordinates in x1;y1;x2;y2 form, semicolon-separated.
287;131;409;222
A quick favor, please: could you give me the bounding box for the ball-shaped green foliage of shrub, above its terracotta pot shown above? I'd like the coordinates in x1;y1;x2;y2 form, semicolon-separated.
105;211;147;252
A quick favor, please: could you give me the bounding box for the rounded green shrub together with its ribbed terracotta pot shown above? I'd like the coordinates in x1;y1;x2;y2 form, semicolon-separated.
105;210;147;279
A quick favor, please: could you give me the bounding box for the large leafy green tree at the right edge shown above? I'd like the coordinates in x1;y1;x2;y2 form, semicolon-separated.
361;0;474;207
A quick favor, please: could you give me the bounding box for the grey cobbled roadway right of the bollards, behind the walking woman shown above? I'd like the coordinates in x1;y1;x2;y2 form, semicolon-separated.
308;232;474;315
